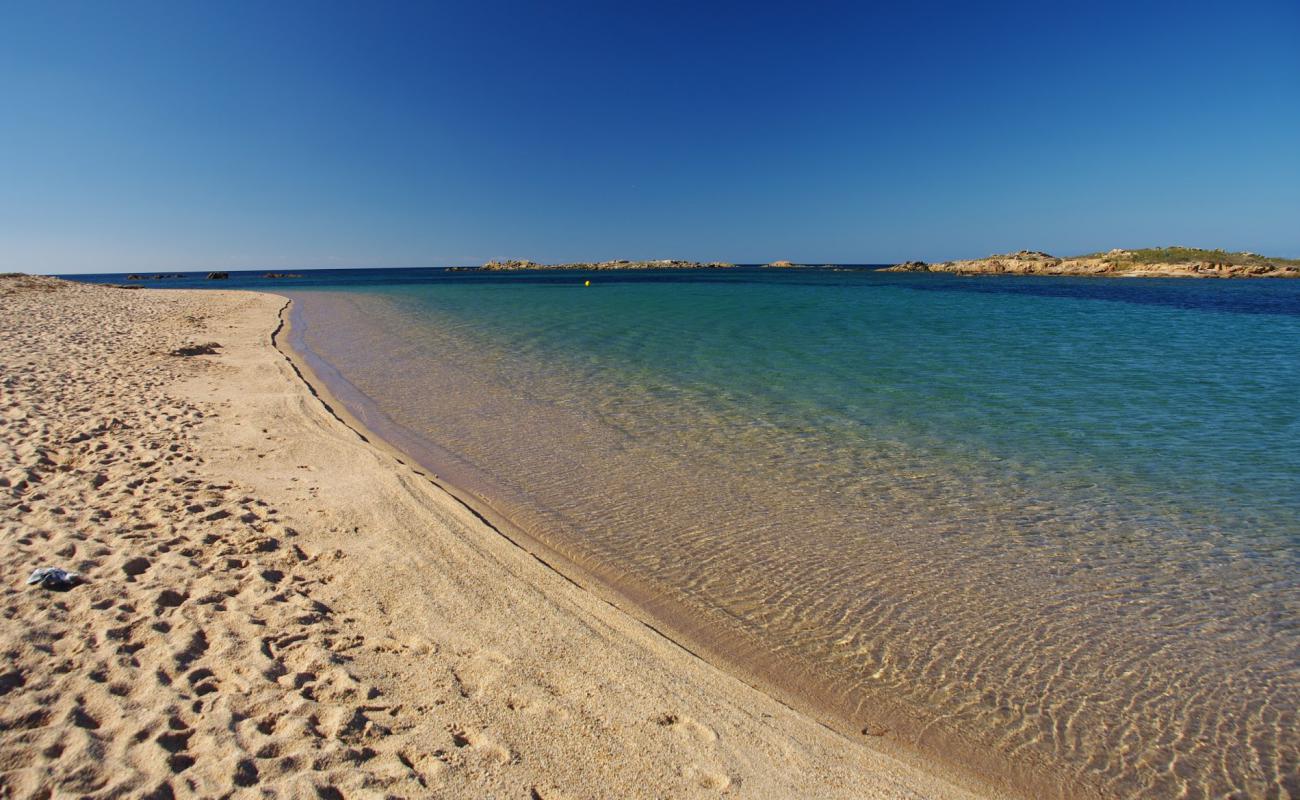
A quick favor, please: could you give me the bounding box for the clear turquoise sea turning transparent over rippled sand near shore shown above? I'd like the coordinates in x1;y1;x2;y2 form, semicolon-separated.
271;271;1300;796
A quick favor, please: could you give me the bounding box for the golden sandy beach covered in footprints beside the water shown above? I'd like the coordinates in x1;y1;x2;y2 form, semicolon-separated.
0;278;993;799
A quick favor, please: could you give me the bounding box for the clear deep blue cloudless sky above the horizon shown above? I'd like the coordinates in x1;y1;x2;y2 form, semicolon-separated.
0;0;1300;273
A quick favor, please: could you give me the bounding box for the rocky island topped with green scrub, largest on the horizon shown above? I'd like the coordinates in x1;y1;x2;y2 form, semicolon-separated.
881;247;1300;278
